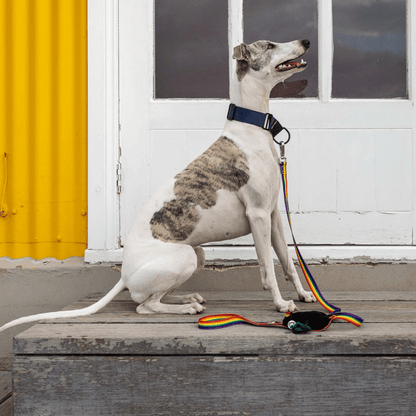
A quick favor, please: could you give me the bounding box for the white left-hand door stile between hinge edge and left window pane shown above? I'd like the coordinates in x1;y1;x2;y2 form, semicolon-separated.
119;0;155;244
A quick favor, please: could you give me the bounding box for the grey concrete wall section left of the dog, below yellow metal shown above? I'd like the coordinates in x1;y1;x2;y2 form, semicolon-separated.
0;258;120;371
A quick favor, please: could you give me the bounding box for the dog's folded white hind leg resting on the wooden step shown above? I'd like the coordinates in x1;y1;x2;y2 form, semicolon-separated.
126;243;205;315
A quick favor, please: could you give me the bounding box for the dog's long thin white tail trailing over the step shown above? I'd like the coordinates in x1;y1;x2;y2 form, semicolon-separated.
0;279;127;332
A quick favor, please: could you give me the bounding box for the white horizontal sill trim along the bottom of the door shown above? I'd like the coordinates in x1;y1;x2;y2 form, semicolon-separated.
85;245;416;263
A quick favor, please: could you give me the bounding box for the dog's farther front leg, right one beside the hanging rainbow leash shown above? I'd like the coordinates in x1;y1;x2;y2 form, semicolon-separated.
271;206;316;302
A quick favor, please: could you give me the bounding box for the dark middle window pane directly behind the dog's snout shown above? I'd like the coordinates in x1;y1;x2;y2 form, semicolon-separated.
243;0;318;98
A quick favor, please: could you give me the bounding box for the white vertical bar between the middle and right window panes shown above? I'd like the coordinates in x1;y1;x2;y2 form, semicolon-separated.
318;0;334;103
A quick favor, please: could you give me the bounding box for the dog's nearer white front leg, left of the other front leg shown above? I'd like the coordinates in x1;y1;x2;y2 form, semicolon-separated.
246;208;297;312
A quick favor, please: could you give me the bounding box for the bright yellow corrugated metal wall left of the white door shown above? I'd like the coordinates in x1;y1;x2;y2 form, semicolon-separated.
0;0;87;259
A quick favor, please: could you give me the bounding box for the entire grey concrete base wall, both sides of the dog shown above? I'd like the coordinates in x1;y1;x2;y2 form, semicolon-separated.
0;258;416;371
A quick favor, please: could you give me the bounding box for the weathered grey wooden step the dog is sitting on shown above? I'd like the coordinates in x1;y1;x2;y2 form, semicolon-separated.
8;292;416;416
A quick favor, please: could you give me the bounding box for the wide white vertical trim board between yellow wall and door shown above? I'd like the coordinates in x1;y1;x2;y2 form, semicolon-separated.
86;0;120;256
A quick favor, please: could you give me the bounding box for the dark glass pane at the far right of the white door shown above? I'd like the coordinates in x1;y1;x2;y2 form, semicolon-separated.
332;0;407;98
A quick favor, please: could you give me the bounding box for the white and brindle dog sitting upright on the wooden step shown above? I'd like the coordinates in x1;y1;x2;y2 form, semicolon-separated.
0;40;315;331
